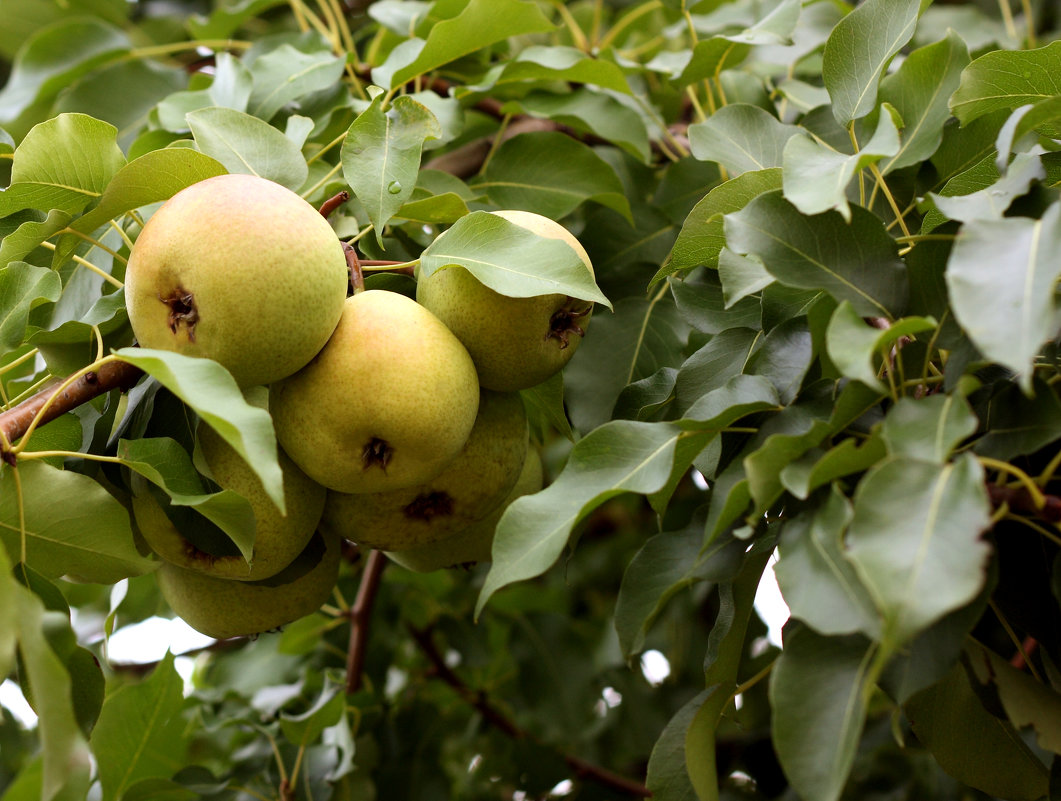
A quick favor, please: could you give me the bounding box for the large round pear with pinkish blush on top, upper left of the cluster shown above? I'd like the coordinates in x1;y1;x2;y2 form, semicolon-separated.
125;175;349;386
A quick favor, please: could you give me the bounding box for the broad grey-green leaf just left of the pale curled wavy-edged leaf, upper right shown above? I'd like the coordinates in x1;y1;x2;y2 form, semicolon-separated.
689;103;800;175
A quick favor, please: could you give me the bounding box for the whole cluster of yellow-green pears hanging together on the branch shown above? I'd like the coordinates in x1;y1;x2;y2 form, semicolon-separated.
125;175;592;638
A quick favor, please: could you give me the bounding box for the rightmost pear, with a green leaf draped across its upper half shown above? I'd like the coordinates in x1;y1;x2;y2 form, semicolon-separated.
416;210;593;391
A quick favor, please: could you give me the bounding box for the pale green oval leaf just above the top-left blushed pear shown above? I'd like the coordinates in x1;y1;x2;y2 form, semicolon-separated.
186;106;309;190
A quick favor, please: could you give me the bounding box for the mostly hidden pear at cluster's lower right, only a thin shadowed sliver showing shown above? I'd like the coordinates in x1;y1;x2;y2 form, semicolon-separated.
384;448;542;573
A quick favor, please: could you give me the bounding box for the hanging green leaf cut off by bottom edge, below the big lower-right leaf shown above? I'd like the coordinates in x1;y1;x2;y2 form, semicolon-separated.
770;627;874;801
